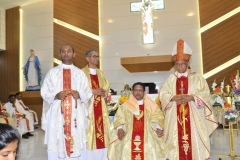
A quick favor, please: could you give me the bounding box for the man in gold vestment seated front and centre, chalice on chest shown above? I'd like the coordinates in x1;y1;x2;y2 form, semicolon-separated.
108;82;168;160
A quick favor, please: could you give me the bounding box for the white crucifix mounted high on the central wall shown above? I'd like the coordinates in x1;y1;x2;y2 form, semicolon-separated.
130;0;164;44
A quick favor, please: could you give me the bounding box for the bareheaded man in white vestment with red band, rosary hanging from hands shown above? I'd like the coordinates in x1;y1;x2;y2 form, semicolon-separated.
41;45;92;160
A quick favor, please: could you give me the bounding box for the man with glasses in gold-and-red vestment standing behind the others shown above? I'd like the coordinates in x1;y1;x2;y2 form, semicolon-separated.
82;49;110;160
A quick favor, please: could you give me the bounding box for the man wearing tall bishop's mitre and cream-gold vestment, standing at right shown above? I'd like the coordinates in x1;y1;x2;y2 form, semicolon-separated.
160;39;218;160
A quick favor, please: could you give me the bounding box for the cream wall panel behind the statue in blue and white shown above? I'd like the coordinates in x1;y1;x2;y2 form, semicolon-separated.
20;0;53;90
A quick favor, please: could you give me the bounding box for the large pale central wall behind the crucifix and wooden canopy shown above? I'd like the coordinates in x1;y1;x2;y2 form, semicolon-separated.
99;0;202;93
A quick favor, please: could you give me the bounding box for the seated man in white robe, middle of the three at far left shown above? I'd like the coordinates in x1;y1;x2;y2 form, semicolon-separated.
4;94;31;139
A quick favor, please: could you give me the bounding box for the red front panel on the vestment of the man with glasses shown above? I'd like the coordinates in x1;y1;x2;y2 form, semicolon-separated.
90;74;106;149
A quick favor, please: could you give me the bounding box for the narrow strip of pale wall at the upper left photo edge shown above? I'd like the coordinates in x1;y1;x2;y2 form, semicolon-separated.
0;7;6;51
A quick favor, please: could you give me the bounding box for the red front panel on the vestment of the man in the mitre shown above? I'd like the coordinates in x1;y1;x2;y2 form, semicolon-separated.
176;77;192;160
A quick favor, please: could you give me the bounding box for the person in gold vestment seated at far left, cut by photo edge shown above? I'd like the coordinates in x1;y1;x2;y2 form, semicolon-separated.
0;102;16;127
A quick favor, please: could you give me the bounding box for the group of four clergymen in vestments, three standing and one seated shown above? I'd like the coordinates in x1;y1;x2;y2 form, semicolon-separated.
35;39;217;160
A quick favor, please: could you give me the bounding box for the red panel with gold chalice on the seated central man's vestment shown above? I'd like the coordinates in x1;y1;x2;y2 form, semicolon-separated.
132;105;144;160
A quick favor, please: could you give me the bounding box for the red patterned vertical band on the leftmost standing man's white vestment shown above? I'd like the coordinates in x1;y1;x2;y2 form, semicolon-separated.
62;69;73;157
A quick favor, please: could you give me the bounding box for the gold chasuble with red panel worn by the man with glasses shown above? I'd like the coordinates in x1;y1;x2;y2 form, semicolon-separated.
82;66;110;150
